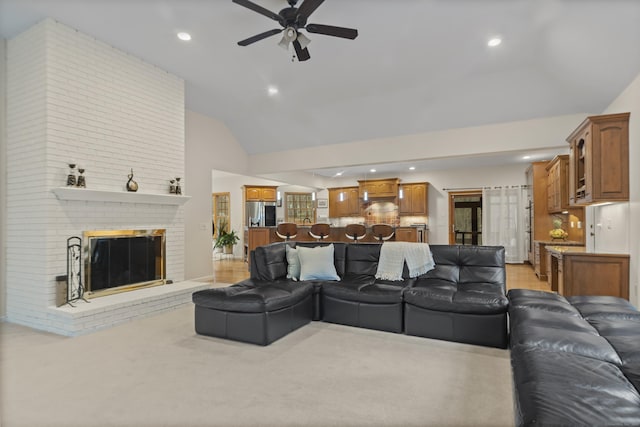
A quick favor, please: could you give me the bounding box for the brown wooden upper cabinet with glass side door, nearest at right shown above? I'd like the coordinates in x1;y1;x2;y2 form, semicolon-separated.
567;113;629;205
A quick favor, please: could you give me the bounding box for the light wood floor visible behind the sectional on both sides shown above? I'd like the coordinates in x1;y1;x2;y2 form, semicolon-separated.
205;259;551;291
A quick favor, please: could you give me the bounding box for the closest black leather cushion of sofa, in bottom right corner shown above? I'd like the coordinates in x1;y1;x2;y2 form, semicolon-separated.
511;347;640;426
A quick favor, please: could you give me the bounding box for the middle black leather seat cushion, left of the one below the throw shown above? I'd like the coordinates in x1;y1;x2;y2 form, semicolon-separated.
322;276;403;304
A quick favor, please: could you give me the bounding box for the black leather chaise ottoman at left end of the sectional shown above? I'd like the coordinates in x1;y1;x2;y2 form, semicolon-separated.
192;279;313;345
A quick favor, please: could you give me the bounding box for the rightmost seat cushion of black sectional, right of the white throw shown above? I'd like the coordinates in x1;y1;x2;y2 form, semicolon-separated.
404;278;509;314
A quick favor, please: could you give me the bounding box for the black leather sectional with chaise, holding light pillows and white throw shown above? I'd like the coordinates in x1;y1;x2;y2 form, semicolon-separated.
193;242;508;348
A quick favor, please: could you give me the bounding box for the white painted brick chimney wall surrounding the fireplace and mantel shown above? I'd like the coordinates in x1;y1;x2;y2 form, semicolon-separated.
7;19;188;330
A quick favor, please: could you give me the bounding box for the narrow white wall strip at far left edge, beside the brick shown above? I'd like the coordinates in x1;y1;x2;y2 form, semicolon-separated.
0;39;7;320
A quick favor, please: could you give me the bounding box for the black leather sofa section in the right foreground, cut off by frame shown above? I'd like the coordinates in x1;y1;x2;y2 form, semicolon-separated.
508;289;640;426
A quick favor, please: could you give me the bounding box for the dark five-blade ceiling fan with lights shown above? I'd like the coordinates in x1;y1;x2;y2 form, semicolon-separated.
233;0;358;61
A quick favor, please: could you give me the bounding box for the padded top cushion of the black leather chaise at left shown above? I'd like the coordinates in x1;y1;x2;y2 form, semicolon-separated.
192;279;313;313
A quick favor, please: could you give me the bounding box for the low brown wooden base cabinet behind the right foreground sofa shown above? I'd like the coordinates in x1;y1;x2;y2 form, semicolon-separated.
547;246;629;300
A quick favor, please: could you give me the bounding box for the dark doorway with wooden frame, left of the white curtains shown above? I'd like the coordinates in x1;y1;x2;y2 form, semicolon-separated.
449;190;482;245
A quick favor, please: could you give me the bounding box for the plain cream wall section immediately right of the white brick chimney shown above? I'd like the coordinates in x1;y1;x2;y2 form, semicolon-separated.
185;110;248;279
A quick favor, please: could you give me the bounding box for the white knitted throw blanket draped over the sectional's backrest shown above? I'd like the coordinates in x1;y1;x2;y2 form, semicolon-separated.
376;242;435;280
